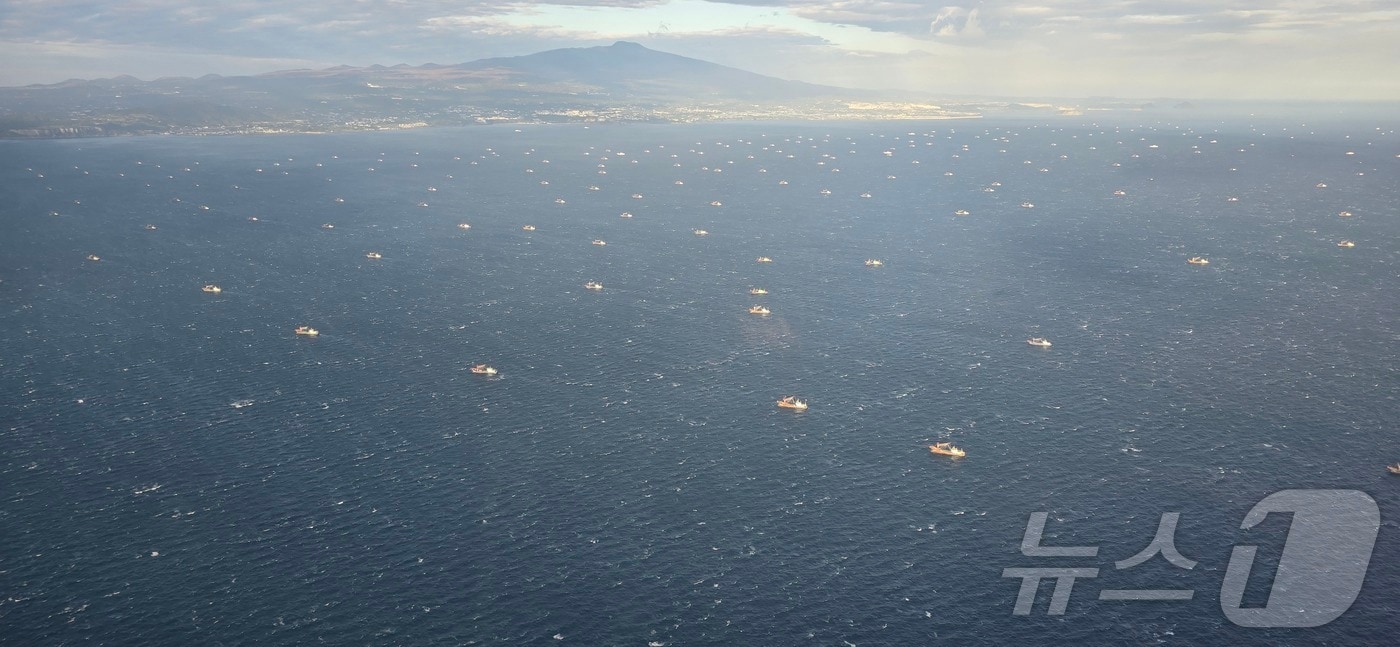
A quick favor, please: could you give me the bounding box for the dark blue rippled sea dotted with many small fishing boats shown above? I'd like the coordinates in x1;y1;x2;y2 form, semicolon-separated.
0;118;1400;646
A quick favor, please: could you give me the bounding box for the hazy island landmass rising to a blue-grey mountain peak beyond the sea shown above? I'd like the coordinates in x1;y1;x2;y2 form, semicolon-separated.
0;42;1008;137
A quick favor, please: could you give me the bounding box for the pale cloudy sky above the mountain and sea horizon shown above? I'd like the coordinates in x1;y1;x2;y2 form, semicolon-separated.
0;0;1400;101
